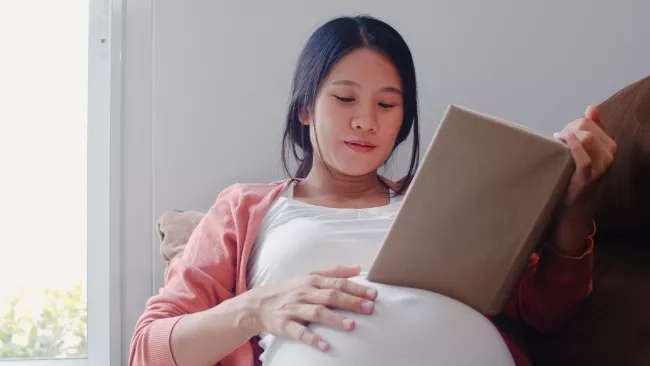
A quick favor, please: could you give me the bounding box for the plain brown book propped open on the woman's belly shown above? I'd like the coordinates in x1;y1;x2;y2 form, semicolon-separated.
367;106;575;315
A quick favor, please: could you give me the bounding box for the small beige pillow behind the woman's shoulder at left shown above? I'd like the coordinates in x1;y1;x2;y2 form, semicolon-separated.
157;211;205;281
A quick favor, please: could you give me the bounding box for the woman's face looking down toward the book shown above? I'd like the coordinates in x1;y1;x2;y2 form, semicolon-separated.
301;49;403;176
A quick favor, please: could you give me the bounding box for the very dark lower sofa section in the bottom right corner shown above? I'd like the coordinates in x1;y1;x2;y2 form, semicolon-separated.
527;237;650;366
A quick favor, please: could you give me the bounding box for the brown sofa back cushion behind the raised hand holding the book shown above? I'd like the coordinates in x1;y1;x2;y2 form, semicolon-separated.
595;76;650;238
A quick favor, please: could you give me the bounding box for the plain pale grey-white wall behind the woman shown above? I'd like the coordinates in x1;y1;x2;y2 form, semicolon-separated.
122;0;650;360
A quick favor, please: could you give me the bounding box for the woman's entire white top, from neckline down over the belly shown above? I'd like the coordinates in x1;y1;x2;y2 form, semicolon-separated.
247;186;514;366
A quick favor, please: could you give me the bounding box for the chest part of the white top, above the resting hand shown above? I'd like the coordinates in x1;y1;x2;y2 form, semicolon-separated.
247;185;403;288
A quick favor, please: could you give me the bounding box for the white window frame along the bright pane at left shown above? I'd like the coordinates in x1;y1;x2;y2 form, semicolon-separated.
0;0;125;366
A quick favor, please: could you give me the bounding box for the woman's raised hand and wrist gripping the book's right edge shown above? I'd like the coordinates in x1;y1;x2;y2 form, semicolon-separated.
553;106;616;255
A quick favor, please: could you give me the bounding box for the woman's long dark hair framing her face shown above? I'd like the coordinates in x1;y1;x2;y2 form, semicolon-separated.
282;16;420;192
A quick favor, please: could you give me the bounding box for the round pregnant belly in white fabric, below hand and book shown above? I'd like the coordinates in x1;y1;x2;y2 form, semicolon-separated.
261;277;514;366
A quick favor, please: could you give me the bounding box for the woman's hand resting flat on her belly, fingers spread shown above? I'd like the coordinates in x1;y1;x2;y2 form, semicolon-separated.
235;266;377;351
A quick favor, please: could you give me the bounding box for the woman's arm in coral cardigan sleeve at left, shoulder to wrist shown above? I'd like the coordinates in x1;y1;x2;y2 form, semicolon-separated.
129;188;250;366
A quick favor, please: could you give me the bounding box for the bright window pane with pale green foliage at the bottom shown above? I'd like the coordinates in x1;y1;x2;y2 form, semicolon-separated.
0;0;89;364
